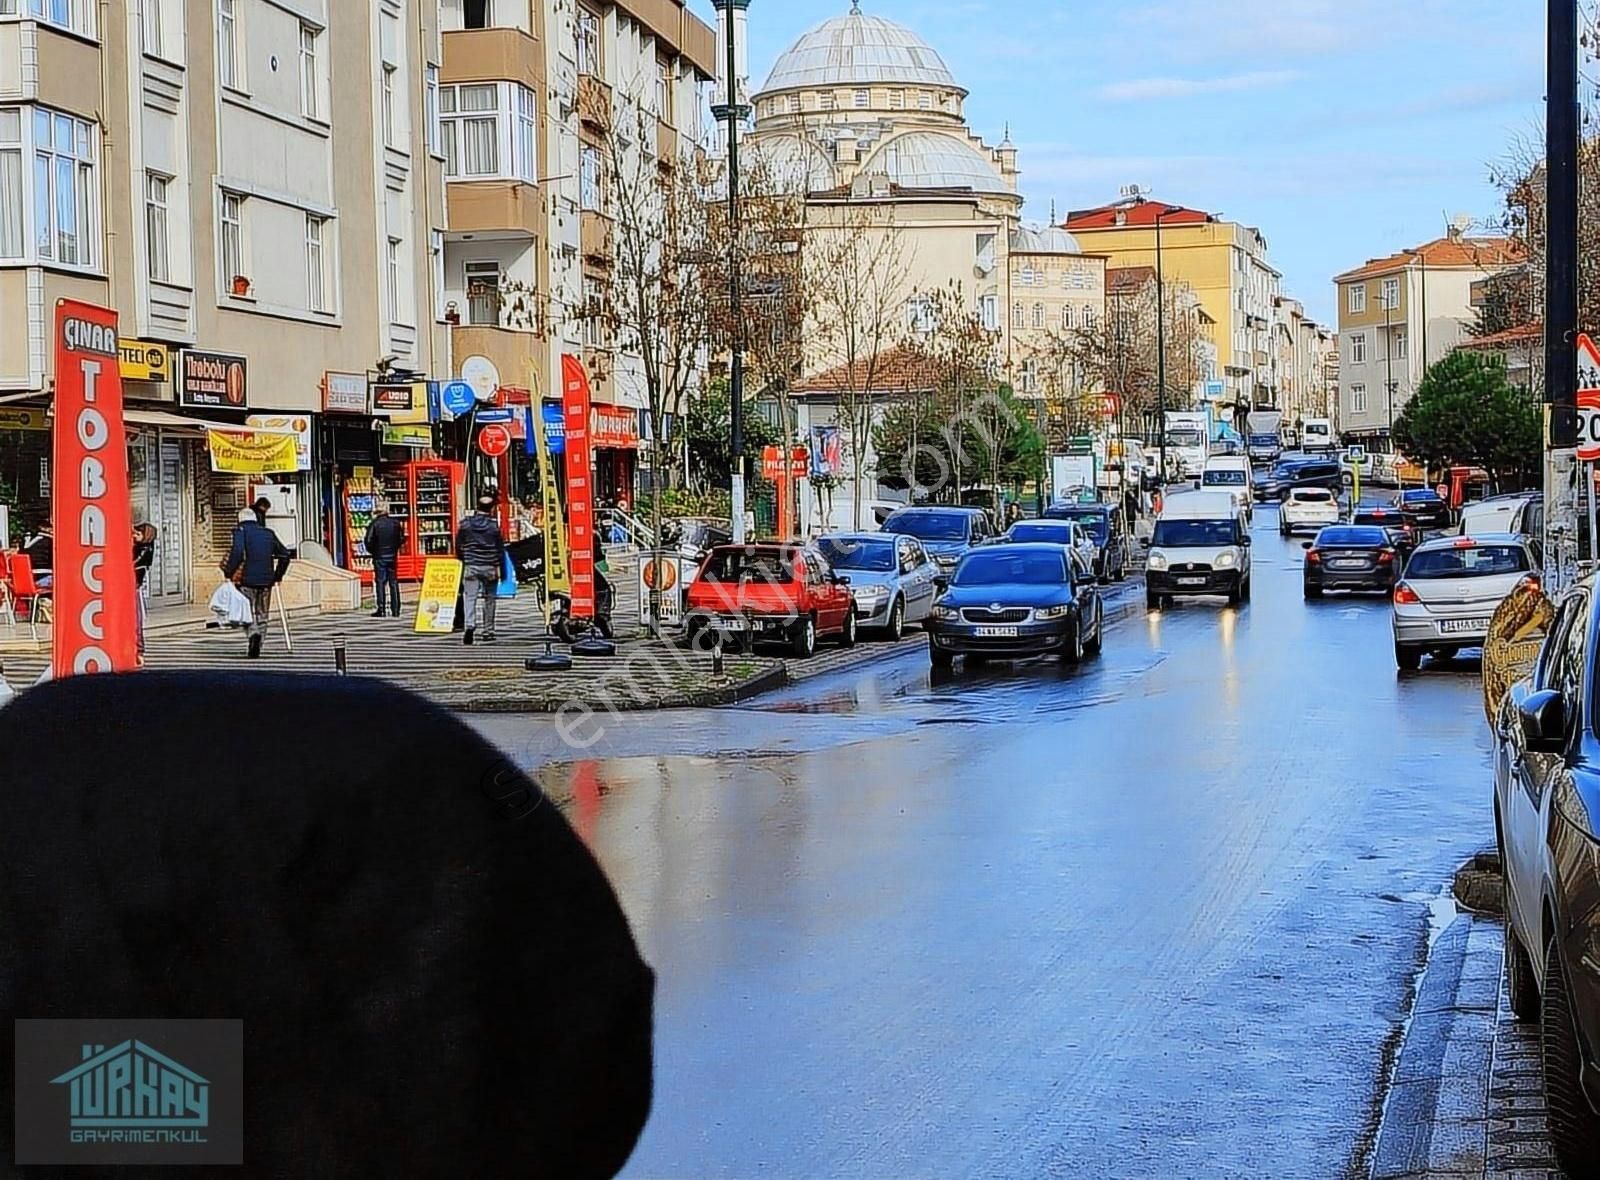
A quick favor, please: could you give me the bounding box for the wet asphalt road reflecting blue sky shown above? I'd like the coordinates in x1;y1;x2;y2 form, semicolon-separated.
480;508;1493;1177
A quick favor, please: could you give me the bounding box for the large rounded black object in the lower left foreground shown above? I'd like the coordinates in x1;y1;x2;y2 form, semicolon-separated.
0;673;653;1177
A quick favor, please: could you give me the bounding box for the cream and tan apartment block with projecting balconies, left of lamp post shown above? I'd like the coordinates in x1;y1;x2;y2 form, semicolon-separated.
438;0;717;499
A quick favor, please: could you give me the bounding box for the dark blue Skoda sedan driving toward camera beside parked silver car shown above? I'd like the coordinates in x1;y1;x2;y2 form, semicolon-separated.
925;544;1106;668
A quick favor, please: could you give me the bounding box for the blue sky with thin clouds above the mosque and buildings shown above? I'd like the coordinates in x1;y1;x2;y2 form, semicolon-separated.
691;0;1544;323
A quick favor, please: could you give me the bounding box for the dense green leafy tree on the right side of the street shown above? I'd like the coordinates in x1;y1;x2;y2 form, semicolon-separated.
1394;352;1542;486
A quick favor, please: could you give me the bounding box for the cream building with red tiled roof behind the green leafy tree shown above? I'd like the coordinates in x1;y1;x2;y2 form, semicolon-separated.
1333;227;1522;448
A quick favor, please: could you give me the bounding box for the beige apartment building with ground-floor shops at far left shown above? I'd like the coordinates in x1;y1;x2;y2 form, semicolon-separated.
0;0;448;606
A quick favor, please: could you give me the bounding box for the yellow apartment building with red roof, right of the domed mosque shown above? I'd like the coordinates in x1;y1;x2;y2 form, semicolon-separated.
1064;200;1282;419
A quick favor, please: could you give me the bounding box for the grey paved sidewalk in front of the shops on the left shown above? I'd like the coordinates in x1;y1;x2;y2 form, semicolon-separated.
0;579;1144;713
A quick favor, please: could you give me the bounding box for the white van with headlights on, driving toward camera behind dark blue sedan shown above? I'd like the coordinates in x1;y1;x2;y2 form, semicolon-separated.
1141;491;1250;611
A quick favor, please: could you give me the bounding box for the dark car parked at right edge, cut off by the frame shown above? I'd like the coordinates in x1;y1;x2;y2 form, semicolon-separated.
1493;577;1600;1177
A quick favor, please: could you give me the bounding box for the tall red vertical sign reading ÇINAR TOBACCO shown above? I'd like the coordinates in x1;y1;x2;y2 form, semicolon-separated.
51;299;139;676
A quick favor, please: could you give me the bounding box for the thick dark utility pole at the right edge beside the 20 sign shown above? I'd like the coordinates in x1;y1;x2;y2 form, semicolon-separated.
1544;0;1594;588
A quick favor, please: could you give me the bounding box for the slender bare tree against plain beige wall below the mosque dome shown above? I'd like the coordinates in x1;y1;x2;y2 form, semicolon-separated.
803;205;910;529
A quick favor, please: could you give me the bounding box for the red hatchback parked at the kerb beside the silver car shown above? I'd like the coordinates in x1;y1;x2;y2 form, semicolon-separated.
683;544;856;657
